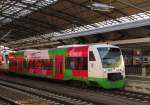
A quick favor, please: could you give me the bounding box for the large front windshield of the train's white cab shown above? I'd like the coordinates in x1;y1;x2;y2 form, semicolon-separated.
97;47;121;68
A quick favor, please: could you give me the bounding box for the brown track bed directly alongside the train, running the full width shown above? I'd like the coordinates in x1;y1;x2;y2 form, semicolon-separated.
0;74;150;105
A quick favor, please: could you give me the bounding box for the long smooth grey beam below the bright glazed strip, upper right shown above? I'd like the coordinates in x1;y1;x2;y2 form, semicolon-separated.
52;19;150;40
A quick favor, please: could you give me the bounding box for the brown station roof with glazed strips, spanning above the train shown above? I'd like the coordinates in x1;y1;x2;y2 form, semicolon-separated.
0;0;150;49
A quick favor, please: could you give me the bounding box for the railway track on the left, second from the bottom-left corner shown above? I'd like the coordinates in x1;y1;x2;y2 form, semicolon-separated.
0;80;95;105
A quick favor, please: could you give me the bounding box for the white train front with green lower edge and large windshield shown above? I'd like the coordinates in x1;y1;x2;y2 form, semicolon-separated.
88;44;125;89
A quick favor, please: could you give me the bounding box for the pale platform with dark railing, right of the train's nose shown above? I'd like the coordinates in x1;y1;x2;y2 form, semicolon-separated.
125;65;150;94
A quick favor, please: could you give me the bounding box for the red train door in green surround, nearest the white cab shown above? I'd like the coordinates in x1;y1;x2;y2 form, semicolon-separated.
55;55;64;80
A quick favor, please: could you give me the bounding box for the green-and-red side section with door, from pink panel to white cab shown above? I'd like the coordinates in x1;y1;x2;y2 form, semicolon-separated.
49;46;88;81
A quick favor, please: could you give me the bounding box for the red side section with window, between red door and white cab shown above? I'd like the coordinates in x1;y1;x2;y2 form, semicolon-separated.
65;46;88;81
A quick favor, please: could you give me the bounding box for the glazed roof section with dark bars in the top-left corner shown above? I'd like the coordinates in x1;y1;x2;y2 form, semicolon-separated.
0;0;58;24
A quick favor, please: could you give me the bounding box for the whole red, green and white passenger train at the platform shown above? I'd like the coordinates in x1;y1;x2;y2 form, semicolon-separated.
0;44;125;89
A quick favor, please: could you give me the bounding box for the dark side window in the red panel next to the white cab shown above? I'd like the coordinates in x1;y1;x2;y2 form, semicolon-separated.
66;57;88;70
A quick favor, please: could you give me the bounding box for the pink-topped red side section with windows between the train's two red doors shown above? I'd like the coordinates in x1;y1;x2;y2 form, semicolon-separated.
25;50;53;78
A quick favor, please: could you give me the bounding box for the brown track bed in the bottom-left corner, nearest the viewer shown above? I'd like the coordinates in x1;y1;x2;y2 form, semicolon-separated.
0;85;50;105
